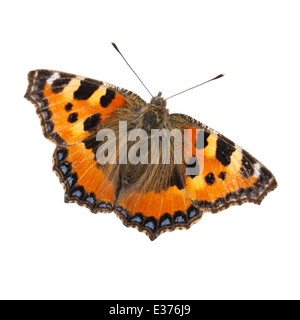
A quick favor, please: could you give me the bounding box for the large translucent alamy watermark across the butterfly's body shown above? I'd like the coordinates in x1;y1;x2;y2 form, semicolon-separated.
96;121;204;175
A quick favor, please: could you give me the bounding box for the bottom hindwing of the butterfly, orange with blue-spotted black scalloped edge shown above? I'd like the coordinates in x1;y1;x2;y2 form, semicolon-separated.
116;185;202;240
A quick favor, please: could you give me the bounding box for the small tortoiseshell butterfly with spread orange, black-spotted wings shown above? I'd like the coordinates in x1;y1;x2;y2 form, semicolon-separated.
25;44;277;240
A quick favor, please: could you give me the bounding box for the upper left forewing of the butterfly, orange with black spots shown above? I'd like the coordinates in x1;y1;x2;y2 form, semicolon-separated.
25;70;145;145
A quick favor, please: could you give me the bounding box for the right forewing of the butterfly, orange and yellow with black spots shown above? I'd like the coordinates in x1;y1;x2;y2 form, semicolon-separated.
171;114;277;212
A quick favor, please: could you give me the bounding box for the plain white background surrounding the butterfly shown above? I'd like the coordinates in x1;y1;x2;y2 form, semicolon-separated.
0;0;300;299
